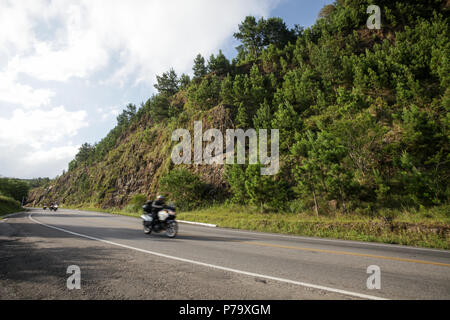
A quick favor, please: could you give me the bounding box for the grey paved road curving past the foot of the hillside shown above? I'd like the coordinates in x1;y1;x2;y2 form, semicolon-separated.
0;209;450;299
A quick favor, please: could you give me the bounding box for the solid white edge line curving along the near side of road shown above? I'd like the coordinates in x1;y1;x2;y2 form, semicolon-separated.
28;213;389;300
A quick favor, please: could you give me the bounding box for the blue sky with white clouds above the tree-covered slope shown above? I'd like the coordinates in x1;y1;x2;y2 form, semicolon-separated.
0;0;333;178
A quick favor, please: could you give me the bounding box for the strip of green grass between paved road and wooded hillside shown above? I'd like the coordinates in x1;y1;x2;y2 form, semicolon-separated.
60;205;450;249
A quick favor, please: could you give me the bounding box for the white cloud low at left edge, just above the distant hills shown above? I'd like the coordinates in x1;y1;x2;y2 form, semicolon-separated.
0;106;87;178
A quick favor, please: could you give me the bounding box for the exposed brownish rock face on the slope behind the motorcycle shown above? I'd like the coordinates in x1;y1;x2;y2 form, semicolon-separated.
29;105;234;208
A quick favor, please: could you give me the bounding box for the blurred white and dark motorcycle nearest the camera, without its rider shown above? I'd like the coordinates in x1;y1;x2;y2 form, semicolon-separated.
141;206;178;238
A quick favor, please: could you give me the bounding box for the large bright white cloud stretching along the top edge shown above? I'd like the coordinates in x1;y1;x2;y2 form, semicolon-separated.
0;0;277;83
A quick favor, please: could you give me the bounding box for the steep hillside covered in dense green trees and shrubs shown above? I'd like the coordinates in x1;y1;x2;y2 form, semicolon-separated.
30;0;450;219
